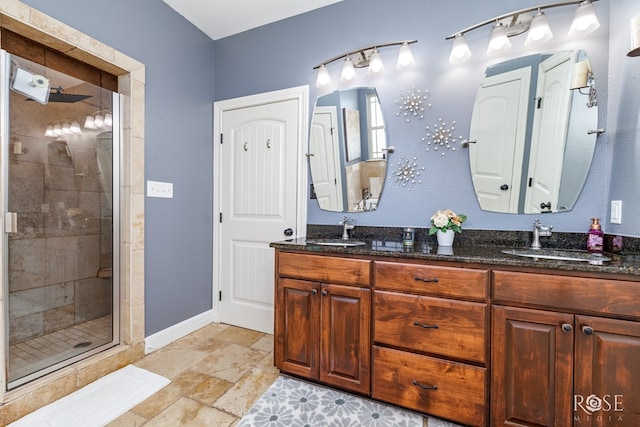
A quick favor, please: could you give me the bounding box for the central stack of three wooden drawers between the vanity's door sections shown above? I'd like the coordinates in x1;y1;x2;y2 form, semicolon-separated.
372;261;489;426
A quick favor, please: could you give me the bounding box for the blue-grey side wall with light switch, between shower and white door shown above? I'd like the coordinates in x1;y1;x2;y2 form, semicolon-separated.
20;0;214;336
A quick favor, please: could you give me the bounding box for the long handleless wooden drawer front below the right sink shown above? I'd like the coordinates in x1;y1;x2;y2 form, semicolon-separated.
493;271;640;317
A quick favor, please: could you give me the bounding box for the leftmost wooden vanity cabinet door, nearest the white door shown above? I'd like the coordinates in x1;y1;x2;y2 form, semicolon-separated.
275;279;320;379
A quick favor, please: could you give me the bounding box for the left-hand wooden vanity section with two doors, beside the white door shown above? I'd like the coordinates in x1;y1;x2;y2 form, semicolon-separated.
275;253;371;394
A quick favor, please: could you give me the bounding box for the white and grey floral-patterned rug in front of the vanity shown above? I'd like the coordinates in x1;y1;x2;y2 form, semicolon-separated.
238;376;456;427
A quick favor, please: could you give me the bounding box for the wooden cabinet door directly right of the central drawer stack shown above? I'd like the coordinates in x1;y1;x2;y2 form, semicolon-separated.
491;306;574;427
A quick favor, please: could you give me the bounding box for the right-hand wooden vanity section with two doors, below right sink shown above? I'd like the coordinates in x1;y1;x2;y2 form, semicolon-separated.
491;271;640;427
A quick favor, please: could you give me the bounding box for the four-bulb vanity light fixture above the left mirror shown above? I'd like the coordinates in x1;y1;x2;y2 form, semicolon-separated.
313;40;417;89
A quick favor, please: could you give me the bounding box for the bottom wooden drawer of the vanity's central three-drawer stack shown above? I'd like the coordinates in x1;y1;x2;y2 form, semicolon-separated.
372;346;486;426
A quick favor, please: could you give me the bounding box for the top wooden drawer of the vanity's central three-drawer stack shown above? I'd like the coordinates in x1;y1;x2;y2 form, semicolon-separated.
375;261;490;300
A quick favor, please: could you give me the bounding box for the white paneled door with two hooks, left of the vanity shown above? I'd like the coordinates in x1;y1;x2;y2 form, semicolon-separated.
214;88;301;333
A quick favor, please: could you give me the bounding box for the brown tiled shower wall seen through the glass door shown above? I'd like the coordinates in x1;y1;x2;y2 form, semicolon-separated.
8;87;112;345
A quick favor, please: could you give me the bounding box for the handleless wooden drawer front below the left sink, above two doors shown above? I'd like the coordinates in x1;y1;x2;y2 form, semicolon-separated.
277;252;371;286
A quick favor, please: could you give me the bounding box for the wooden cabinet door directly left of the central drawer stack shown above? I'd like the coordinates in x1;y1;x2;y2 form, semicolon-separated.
320;284;371;394
